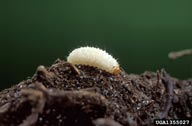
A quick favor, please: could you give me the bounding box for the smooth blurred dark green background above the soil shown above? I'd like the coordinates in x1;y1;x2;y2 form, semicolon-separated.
0;0;192;89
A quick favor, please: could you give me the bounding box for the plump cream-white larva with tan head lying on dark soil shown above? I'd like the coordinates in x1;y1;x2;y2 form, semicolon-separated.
67;47;120;74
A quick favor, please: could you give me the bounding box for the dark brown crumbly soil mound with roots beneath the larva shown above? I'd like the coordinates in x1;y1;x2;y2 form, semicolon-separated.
0;60;192;126
